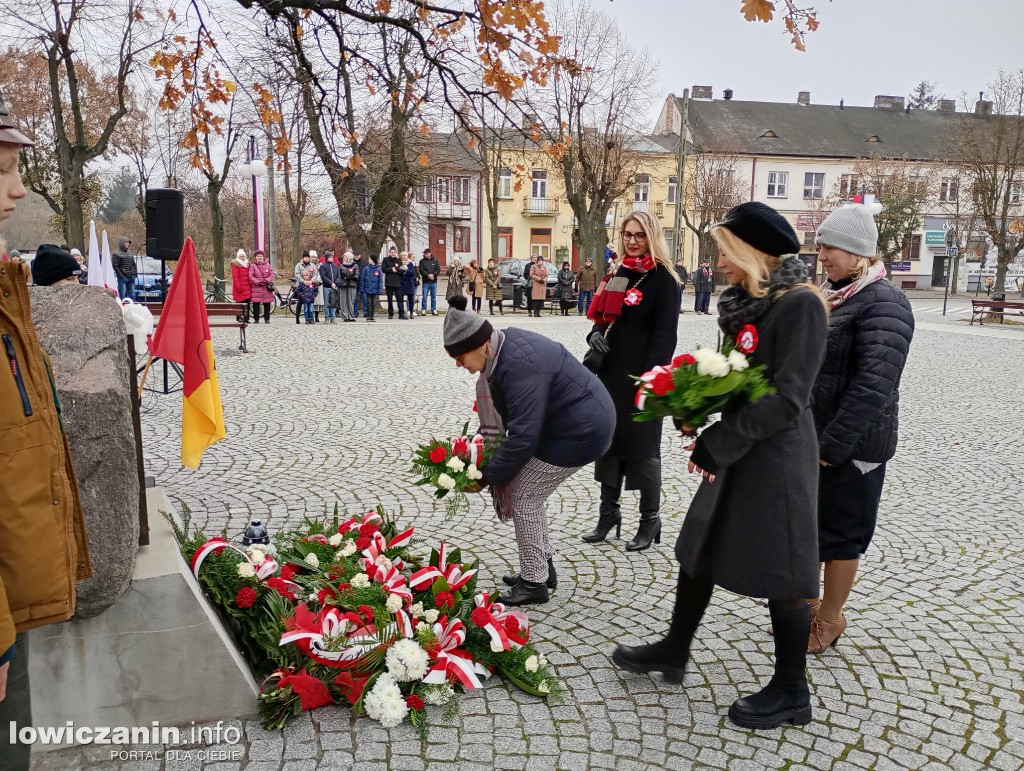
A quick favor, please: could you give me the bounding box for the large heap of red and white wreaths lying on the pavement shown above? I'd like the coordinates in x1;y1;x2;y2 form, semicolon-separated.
172;501;560;731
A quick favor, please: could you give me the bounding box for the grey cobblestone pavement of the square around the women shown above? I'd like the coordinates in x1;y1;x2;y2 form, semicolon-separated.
37;313;1024;771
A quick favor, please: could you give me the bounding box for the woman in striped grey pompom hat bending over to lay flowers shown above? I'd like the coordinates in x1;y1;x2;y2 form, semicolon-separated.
444;295;615;605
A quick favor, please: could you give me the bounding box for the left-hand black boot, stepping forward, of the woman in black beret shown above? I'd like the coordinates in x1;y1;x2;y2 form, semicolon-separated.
611;570;712;683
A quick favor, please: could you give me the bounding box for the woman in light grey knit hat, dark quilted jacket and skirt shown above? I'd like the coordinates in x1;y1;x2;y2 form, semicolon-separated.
808;204;913;653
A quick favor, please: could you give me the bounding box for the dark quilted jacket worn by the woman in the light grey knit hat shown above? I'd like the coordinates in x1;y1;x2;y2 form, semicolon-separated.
812;280;913;465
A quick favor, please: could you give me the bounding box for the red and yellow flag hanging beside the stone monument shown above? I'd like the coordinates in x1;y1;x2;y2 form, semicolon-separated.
150;238;225;462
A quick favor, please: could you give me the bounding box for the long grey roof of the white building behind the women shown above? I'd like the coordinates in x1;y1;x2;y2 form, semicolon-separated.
680;99;973;160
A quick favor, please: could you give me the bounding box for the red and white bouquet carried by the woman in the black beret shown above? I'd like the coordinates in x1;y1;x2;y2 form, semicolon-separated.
633;325;774;429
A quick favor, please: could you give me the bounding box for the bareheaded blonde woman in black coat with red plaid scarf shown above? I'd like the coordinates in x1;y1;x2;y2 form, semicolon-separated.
583;207;679;551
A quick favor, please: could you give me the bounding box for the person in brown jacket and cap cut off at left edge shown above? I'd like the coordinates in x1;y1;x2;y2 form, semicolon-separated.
0;103;91;771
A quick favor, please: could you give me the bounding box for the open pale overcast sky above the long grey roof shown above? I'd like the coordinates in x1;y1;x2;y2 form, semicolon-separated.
591;0;1024;117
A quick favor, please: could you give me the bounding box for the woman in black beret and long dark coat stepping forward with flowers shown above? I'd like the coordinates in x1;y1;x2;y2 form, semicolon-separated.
612;202;827;728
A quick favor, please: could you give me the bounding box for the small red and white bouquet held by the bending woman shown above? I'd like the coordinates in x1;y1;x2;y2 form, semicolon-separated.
413;423;501;517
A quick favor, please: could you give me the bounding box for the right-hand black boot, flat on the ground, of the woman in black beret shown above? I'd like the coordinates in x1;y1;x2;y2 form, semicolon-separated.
729;600;811;728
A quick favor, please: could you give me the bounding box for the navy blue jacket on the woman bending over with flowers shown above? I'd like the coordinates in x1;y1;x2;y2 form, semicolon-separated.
480;327;615;485
